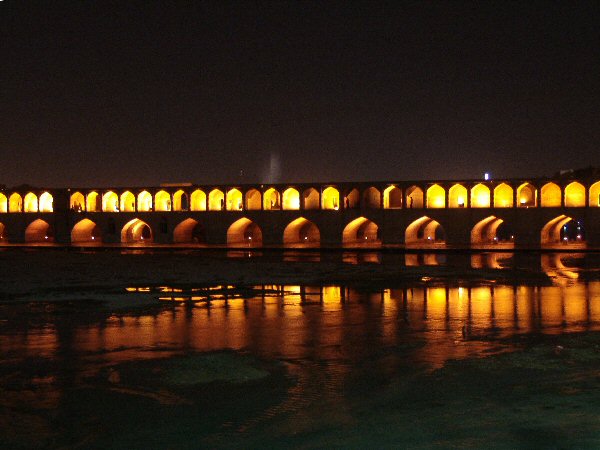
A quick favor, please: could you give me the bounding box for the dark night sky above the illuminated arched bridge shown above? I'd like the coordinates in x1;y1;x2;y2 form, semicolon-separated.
0;0;600;187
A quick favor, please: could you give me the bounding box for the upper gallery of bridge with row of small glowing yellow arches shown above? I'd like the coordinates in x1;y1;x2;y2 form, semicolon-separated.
0;177;600;213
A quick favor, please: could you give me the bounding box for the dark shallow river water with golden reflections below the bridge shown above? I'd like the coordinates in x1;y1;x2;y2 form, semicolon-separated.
0;251;600;448
